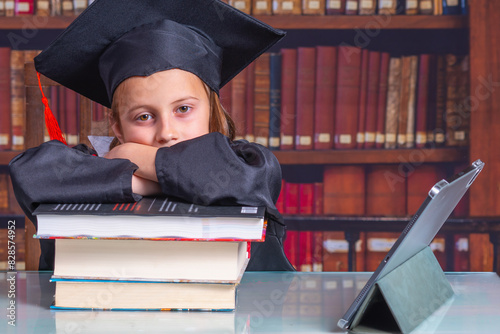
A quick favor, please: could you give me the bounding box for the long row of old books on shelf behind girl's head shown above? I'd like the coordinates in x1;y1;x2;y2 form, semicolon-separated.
0;46;471;150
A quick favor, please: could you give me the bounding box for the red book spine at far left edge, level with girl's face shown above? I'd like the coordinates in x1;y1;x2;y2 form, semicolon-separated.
0;47;12;151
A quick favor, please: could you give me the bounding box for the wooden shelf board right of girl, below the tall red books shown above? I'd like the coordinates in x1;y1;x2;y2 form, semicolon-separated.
273;148;469;165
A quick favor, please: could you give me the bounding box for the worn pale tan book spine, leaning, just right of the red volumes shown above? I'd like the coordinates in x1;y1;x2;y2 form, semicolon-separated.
384;57;401;149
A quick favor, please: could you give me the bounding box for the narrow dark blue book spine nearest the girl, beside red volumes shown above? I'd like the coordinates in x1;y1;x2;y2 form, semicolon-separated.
269;53;281;150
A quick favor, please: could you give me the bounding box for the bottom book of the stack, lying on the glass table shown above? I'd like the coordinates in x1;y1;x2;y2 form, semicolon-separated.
51;278;236;311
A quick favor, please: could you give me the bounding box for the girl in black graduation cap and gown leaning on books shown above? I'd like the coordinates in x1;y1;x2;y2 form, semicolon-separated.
10;0;293;270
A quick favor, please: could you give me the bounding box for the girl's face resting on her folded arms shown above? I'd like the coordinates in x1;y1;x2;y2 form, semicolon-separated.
112;69;210;147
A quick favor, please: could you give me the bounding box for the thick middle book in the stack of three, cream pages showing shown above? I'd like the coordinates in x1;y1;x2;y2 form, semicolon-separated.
53;239;248;283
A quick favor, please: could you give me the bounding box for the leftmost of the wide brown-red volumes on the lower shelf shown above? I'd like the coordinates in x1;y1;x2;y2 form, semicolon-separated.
323;165;365;215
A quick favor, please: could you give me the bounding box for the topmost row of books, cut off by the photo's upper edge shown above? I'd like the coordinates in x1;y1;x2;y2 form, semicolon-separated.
0;0;467;16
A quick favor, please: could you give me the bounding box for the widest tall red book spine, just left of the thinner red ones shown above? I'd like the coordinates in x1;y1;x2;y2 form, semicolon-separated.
334;46;361;149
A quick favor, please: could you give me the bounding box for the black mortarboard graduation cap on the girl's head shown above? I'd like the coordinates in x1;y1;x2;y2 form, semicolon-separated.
35;0;285;107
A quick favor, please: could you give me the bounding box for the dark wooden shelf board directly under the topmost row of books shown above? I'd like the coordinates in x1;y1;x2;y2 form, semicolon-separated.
0;15;468;30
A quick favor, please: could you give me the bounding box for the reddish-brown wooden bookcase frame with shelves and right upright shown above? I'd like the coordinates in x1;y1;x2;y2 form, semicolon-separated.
0;0;500;270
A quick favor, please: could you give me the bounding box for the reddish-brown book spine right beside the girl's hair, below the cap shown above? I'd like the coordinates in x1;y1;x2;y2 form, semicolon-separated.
231;70;247;140
